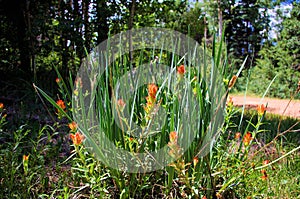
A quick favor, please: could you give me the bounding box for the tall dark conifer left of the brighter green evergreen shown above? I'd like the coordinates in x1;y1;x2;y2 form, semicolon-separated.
221;0;271;68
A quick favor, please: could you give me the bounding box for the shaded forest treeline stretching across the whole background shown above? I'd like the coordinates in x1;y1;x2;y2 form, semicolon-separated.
0;0;299;98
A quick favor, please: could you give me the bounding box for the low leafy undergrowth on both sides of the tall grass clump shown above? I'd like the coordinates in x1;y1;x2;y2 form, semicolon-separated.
0;89;300;198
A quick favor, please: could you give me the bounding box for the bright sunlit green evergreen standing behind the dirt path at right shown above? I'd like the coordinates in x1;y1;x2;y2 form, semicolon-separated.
244;3;300;98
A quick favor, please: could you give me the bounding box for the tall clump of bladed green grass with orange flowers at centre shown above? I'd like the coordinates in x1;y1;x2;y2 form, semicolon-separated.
36;29;227;198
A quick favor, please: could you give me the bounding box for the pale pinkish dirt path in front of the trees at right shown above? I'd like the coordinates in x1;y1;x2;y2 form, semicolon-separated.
230;95;300;119
